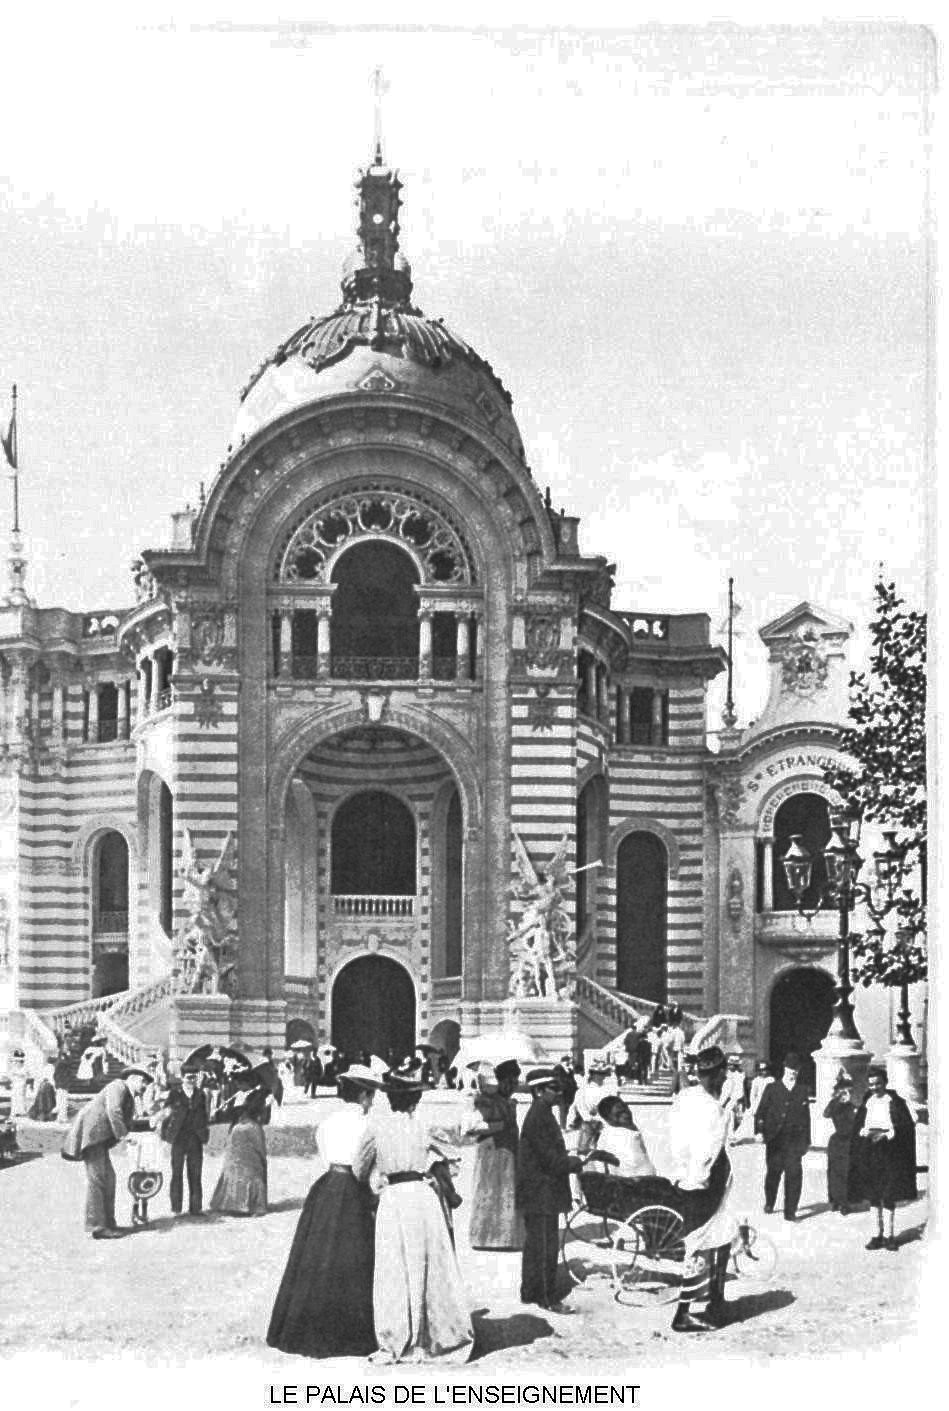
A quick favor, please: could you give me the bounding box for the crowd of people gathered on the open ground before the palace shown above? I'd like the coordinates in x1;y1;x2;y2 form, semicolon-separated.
51;1046;915;1363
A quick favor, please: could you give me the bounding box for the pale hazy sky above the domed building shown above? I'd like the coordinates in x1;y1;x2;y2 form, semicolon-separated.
0;16;935;722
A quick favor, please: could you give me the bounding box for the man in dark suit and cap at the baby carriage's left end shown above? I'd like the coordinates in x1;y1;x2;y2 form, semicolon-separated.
515;1068;582;1314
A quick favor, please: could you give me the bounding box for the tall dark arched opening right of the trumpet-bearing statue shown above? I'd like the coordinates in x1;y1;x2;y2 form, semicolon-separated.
616;832;668;1005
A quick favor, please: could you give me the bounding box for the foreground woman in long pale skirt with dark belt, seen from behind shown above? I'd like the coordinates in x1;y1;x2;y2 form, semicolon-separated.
353;1075;474;1363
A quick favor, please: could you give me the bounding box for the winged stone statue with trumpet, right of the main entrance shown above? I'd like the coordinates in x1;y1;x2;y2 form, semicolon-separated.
508;831;599;999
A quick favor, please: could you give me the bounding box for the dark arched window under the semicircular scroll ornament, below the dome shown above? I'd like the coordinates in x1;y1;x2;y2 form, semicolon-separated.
330;542;419;680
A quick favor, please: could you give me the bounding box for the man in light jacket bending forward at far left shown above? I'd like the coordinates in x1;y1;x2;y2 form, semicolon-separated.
62;1068;148;1239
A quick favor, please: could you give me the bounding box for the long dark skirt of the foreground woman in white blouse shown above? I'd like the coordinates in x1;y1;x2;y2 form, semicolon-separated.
267;1168;376;1357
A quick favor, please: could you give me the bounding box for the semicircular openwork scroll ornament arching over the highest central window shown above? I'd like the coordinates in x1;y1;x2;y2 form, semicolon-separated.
276;487;474;584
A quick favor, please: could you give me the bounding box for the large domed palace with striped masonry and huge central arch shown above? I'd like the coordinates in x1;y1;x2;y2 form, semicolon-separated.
0;151;919;1089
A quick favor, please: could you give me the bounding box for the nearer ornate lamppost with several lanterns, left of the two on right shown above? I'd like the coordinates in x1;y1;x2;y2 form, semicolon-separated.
781;813;904;1110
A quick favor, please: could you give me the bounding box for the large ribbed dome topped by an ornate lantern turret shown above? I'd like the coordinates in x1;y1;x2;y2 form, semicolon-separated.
231;152;523;460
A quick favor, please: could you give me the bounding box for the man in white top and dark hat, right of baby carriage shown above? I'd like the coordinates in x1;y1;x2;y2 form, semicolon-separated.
670;1046;737;1332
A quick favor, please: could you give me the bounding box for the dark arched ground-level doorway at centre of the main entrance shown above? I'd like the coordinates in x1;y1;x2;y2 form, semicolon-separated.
331;955;416;1062
